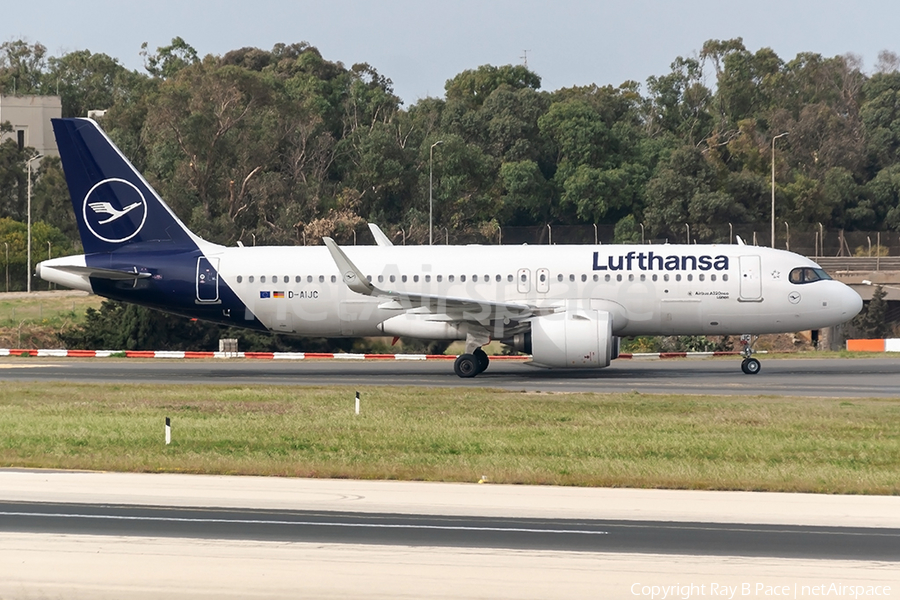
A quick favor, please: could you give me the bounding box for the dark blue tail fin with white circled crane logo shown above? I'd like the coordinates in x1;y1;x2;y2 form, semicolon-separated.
52;119;202;254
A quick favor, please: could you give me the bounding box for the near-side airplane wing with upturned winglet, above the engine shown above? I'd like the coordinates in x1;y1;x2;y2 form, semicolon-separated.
323;237;557;325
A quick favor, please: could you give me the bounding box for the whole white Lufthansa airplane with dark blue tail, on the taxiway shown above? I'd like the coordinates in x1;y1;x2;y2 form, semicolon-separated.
36;118;862;377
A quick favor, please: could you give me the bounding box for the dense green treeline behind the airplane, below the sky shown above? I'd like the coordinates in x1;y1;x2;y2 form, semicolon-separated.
0;38;900;254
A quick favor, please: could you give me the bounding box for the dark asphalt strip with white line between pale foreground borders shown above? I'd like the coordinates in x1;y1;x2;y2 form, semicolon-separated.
0;502;900;562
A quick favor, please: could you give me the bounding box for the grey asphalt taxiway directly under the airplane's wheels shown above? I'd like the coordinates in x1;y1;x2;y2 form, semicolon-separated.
0;357;900;398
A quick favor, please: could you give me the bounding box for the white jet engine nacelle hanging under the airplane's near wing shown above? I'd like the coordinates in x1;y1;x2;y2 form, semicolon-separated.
531;308;619;369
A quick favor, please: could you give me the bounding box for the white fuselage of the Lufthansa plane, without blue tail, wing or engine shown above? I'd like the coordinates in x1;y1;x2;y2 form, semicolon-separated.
188;245;861;337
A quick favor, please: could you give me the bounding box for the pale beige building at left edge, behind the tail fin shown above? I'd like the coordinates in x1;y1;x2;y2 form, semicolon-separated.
0;96;62;156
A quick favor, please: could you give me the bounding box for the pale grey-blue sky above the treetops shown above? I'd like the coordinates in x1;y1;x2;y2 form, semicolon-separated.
0;0;900;106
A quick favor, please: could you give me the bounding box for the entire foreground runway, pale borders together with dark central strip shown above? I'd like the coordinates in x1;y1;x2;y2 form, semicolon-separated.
0;470;900;599
